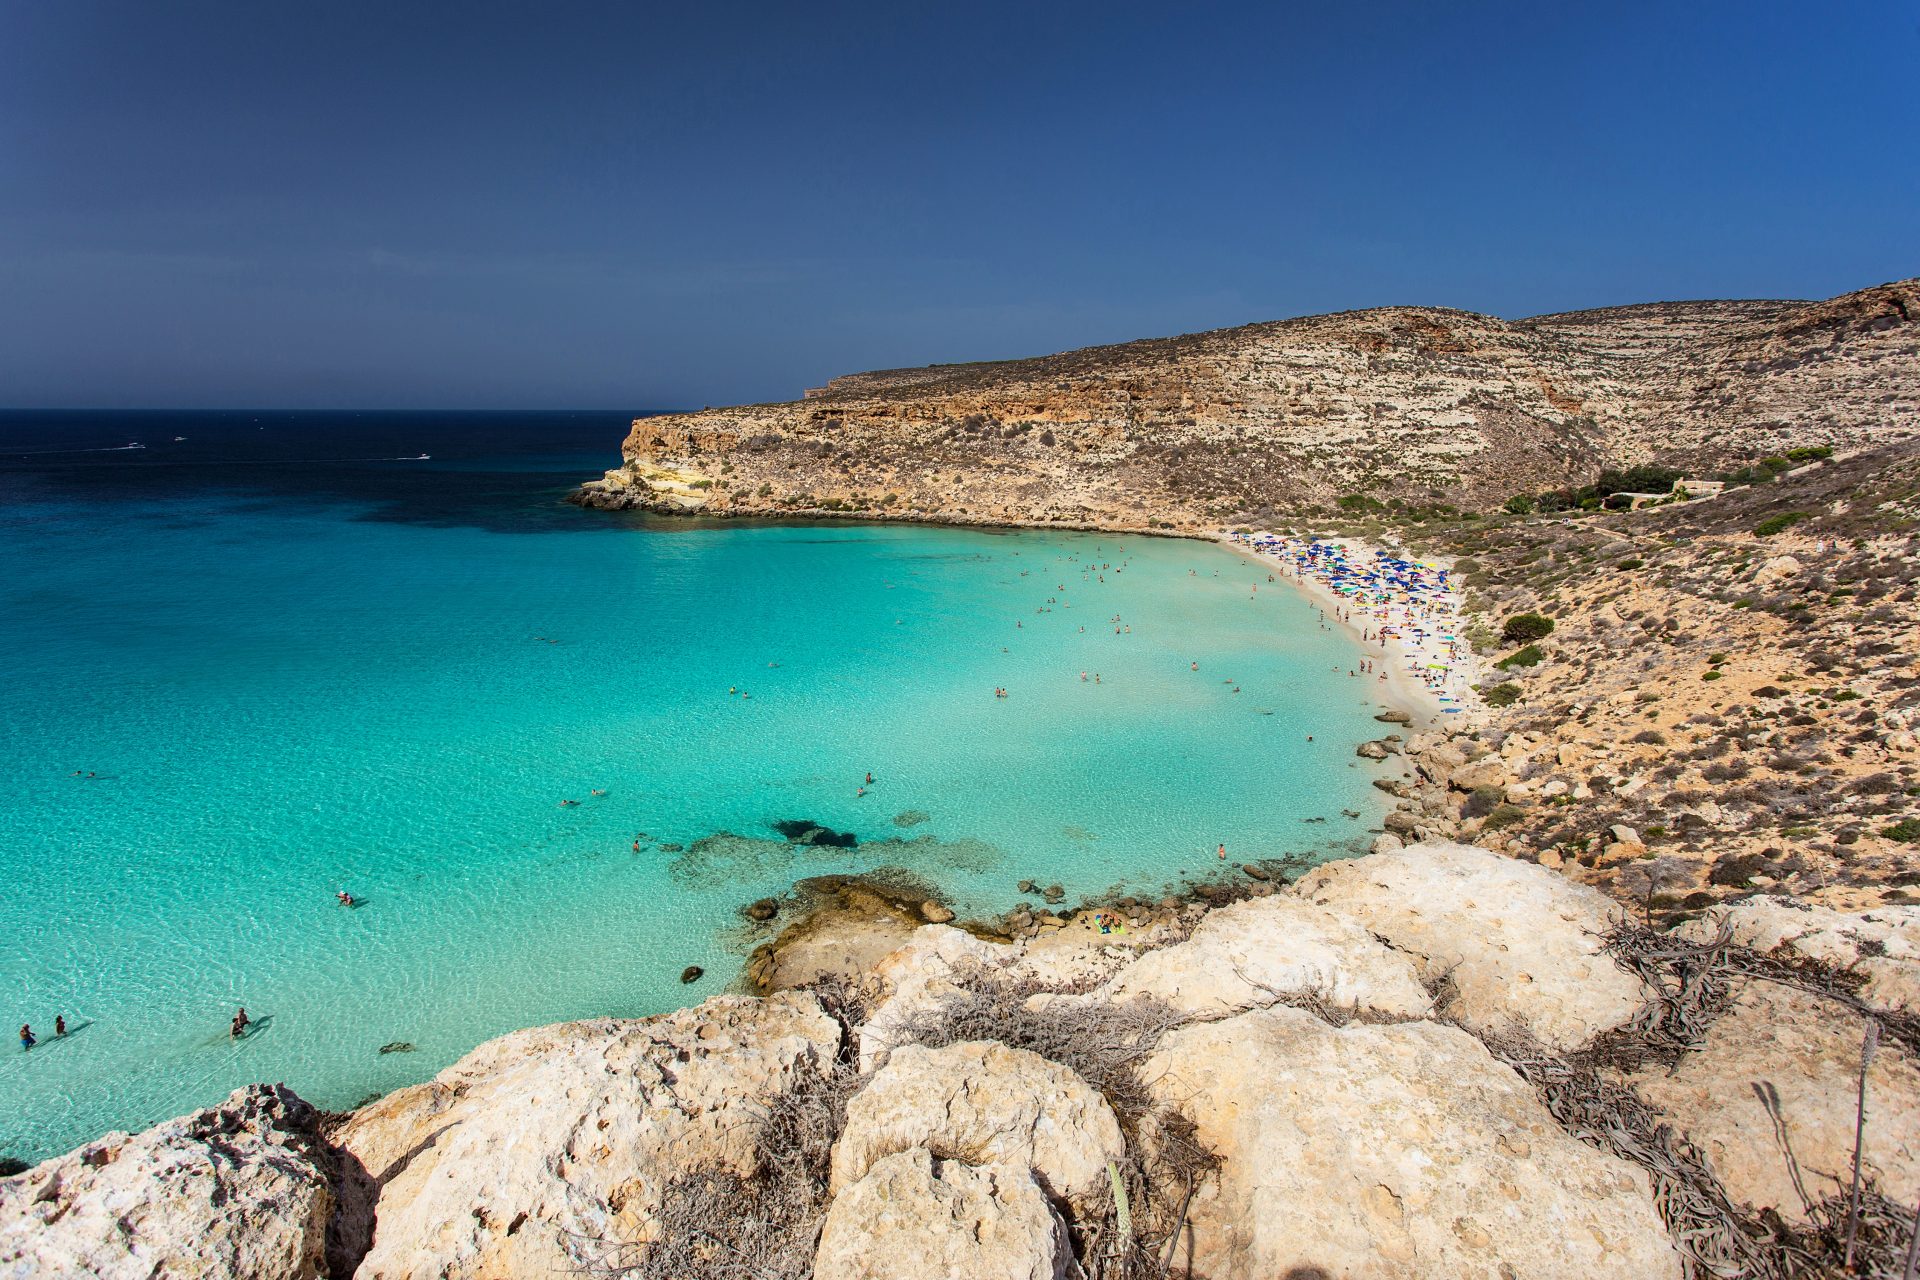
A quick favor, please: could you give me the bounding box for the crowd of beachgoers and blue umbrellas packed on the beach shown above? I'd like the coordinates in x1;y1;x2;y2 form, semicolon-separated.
1227;533;1473;716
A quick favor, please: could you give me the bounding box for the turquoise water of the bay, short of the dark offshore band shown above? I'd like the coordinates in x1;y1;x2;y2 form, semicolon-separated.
0;412;1379;1159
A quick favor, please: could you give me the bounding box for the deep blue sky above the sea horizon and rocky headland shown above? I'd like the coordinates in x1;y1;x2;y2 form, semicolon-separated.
0;0;1920;409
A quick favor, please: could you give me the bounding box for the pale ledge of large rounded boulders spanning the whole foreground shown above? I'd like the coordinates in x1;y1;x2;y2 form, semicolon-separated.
0;842;1920;1280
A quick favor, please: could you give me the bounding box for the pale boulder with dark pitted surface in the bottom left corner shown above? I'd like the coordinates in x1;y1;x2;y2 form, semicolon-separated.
0;1084;351;1280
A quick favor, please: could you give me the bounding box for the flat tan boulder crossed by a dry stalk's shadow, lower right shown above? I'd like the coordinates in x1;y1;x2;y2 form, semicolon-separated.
1632;983;1920;1219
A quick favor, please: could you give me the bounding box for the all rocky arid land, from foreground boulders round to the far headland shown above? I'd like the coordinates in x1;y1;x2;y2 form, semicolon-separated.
0;280;1920;1280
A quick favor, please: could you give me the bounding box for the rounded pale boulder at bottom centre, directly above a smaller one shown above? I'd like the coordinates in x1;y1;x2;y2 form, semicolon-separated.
831;1040;1125;1207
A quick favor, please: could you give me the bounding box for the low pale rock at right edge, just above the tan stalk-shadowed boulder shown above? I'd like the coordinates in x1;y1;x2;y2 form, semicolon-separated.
1686;898;1920;1013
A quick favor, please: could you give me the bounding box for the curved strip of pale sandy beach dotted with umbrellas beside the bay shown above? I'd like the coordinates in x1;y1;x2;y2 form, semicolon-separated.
1217;532;1484;727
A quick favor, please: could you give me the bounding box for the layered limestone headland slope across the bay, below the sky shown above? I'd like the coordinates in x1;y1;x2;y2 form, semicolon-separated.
578;280;1920;530
